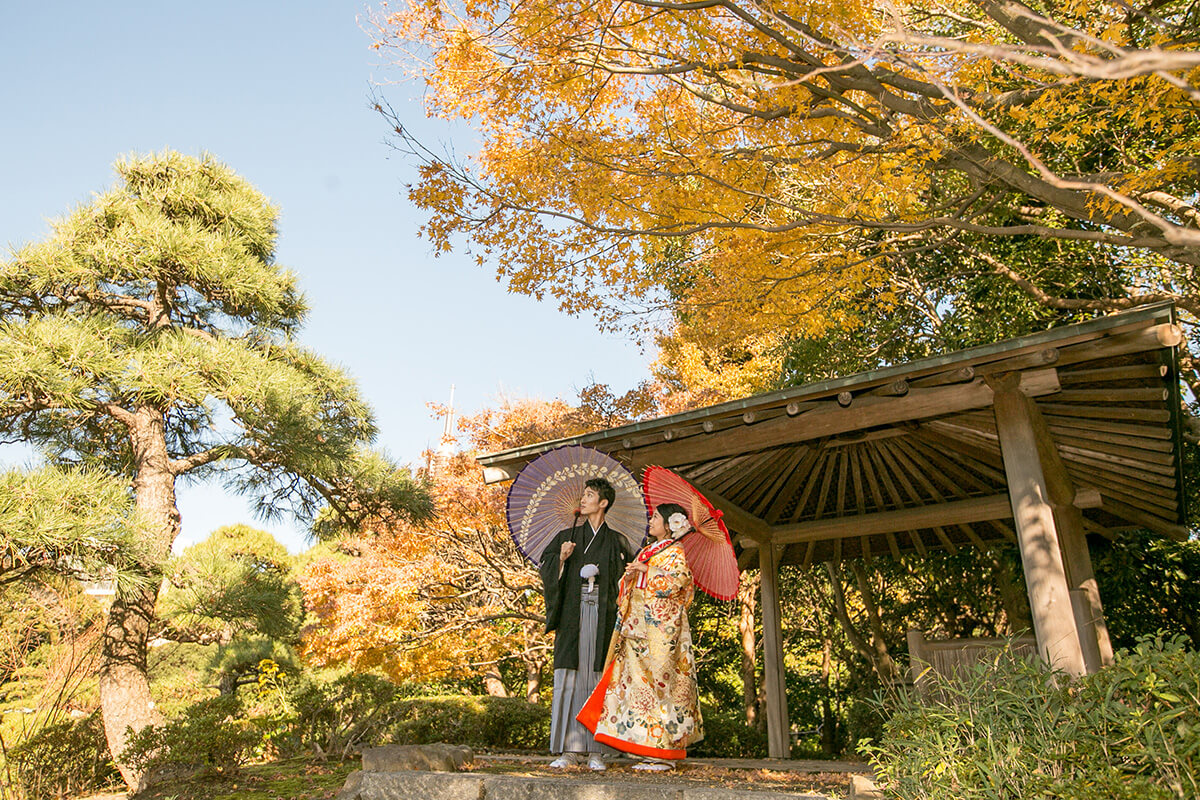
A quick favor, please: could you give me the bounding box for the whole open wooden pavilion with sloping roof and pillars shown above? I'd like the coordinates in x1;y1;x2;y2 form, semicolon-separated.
479;303;1187;758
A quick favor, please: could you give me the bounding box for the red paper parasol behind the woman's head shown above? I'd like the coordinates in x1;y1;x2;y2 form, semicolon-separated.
642;467;738;600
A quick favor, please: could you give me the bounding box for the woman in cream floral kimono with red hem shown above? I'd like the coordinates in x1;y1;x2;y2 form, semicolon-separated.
578;503;704;770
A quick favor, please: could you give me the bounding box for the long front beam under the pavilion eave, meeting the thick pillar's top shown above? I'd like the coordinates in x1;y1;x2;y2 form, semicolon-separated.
630;368;1060;471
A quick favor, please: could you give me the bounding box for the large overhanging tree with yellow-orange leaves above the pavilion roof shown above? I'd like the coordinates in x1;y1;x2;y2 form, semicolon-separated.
376;0;1200;357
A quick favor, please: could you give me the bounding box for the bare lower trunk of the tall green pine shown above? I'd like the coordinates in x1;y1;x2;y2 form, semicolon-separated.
100;408;180;793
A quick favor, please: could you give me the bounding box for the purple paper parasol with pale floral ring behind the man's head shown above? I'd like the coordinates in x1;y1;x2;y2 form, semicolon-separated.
508;445;647;564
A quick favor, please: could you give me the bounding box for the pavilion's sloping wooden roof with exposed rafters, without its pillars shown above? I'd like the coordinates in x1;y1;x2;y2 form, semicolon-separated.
479;305;1186;565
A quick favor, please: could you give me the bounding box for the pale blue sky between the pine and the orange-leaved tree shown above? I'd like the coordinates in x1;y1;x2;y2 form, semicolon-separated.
0;0;648;552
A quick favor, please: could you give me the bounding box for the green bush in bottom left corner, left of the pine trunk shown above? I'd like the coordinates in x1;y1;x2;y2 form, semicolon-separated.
8;711;120;798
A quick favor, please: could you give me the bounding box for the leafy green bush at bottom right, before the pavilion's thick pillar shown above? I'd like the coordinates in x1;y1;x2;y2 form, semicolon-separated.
860;637;1200;800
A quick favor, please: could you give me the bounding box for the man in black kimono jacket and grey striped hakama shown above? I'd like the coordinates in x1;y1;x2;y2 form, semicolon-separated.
540;477;634;771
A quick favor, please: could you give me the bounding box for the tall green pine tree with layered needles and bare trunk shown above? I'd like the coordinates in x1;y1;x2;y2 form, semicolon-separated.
0;152;430;788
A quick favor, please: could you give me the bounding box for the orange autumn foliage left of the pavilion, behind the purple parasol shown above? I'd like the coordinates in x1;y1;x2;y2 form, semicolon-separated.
300;398;652;685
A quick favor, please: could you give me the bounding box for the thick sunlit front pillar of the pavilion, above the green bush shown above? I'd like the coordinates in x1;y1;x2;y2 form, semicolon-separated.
988;373;1086;676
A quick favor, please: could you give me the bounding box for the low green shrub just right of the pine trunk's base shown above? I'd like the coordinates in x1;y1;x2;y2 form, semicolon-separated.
124;696;262;772
